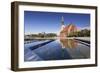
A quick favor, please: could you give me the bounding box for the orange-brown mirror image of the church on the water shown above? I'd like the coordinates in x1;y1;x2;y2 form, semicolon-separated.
60;39;78;49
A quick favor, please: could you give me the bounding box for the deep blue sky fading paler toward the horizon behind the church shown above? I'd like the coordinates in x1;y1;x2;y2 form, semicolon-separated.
24;11;90;34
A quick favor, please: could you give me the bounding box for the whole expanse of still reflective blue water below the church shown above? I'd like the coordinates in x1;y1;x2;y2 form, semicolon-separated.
24;38;90;61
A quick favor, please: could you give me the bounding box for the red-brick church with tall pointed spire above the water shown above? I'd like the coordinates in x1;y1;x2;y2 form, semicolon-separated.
60;16;77;37
